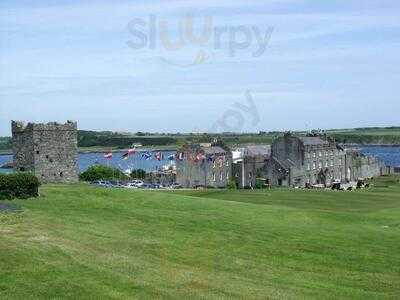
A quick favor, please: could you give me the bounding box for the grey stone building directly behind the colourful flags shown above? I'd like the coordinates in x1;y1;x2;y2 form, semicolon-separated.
176;144;232;188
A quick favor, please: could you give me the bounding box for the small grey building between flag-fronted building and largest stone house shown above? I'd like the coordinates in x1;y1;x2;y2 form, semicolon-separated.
232;145;271;188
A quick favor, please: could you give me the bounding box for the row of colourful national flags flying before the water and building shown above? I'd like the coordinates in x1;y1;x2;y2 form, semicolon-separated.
104;149;225;162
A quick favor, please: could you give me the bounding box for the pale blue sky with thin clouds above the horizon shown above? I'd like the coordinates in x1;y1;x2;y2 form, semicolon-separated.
0;0;400;135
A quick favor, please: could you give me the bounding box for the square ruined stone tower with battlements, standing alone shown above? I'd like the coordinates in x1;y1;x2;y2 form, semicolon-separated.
11;121;79;183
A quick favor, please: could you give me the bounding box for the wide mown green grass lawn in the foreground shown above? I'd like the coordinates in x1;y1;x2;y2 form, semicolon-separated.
0;177;400;299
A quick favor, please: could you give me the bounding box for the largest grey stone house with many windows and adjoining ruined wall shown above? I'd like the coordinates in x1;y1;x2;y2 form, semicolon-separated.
264;133;383;187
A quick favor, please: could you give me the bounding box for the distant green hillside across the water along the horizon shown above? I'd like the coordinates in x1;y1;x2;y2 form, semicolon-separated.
0;127;400;151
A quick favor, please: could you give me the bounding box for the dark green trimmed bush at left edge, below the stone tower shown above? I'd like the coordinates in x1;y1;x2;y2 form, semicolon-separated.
0;173;40;200
